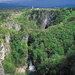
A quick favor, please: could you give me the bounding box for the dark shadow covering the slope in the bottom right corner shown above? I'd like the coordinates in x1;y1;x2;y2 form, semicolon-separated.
41;52;75;75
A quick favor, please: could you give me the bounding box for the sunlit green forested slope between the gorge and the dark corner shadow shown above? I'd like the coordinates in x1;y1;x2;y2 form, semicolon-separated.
29;20;75;75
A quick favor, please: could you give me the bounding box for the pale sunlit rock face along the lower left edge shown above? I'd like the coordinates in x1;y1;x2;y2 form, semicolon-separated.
0;35;10;75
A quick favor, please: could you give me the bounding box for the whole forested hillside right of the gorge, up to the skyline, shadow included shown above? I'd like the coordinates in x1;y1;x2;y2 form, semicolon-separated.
29;9;75;75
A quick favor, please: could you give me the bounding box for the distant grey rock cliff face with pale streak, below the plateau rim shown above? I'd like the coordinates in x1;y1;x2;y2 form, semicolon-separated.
28;10;56;29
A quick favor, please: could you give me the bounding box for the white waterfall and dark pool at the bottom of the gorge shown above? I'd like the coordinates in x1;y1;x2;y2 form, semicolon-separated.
27;59;38;75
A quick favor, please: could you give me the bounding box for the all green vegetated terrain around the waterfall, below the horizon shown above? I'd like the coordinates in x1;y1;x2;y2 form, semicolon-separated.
0;8;75;75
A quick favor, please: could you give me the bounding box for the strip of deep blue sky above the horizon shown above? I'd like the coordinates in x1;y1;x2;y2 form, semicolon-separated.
0;0;75;7
